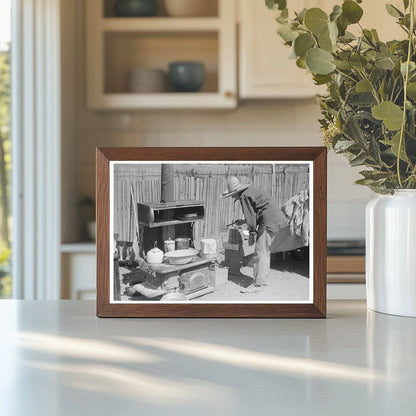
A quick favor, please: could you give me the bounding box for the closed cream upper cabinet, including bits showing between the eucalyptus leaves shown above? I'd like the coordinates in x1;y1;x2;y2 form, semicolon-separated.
239;0;404;99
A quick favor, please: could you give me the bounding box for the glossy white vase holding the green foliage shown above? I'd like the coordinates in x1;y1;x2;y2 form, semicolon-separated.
366;190;416;317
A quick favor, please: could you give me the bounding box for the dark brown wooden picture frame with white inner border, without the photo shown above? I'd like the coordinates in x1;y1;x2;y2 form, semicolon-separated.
96;147;327;318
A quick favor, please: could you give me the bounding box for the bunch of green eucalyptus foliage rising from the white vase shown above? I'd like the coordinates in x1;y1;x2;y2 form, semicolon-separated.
266;0;416;194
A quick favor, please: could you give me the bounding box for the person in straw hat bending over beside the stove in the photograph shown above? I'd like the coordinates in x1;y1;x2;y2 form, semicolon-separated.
221;176;288;287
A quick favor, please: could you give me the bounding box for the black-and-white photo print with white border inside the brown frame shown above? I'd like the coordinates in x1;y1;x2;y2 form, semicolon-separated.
109;161;313;303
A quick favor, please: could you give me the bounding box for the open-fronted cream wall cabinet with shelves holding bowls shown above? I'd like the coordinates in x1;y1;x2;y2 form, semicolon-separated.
86;0;237;109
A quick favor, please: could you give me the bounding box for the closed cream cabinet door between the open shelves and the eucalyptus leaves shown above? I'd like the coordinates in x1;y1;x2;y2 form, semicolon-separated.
239;0;320;98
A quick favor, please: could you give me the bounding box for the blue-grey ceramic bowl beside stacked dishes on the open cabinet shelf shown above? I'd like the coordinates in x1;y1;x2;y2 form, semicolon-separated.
169;62;205;92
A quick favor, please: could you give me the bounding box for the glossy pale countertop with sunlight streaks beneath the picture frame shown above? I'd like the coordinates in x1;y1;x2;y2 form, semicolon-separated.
0;301;416;416
